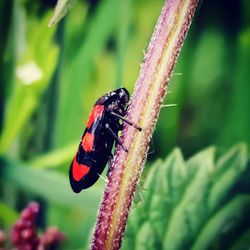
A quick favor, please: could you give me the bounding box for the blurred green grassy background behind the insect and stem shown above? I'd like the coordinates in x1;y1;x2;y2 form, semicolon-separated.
0;0;250;249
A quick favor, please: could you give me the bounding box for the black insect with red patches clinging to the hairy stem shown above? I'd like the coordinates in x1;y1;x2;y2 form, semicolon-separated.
69;88;141;193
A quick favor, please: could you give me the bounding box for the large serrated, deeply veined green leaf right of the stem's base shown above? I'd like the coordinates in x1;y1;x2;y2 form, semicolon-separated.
123;144;250;250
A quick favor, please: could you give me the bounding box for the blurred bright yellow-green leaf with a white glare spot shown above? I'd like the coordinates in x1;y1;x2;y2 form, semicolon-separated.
0;10;58;154
